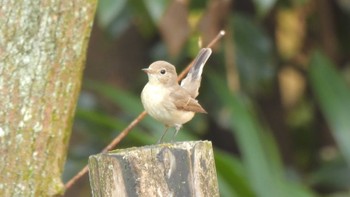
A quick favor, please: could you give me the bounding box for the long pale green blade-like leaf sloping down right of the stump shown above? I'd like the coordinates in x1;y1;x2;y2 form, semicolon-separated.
209;74;312;197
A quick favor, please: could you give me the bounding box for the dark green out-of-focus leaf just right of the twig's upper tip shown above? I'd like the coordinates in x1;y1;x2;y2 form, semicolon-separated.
231;14;276;95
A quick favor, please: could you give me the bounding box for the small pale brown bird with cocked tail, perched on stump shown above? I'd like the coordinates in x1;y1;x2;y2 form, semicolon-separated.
141;48;212;143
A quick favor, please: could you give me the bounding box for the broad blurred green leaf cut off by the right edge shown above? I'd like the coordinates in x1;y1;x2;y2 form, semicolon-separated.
310;52;350;165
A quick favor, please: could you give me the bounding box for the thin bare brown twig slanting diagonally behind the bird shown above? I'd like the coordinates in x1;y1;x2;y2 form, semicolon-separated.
64;30;225;190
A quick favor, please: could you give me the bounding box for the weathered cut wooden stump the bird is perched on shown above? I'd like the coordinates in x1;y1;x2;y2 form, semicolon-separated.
89;141;219;197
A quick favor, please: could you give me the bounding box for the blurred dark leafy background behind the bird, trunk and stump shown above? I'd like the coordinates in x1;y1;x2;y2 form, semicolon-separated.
63;0;350;197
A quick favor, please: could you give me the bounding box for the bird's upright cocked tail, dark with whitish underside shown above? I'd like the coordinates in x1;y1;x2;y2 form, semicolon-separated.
181;48;212;98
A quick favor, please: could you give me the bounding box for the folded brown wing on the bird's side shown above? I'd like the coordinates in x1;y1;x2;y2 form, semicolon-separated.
170;87;207;113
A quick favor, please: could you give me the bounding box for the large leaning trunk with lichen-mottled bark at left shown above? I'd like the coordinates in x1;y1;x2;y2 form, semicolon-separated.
0;0;96;196
